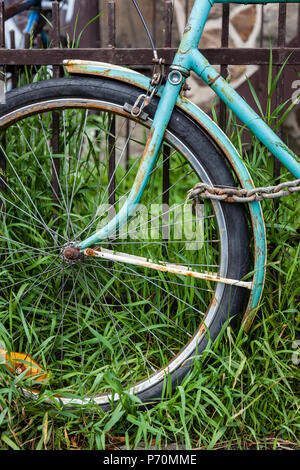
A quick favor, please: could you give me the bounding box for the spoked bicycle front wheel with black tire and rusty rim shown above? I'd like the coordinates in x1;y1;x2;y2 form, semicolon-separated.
0;78;249;407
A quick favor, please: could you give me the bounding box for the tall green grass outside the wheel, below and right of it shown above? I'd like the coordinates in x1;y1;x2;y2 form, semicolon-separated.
0;59;300;449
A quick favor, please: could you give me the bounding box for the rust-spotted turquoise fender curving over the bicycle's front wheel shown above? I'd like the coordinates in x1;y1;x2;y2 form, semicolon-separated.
64;60;267;332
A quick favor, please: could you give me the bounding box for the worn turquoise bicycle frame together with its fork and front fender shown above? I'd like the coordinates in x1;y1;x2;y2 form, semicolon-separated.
65;0;300;327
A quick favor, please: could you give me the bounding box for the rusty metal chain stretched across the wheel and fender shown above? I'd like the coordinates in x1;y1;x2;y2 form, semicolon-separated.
186;179;300;203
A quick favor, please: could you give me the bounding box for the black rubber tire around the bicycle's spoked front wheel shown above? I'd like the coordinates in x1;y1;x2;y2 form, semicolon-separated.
0;77;250;408
